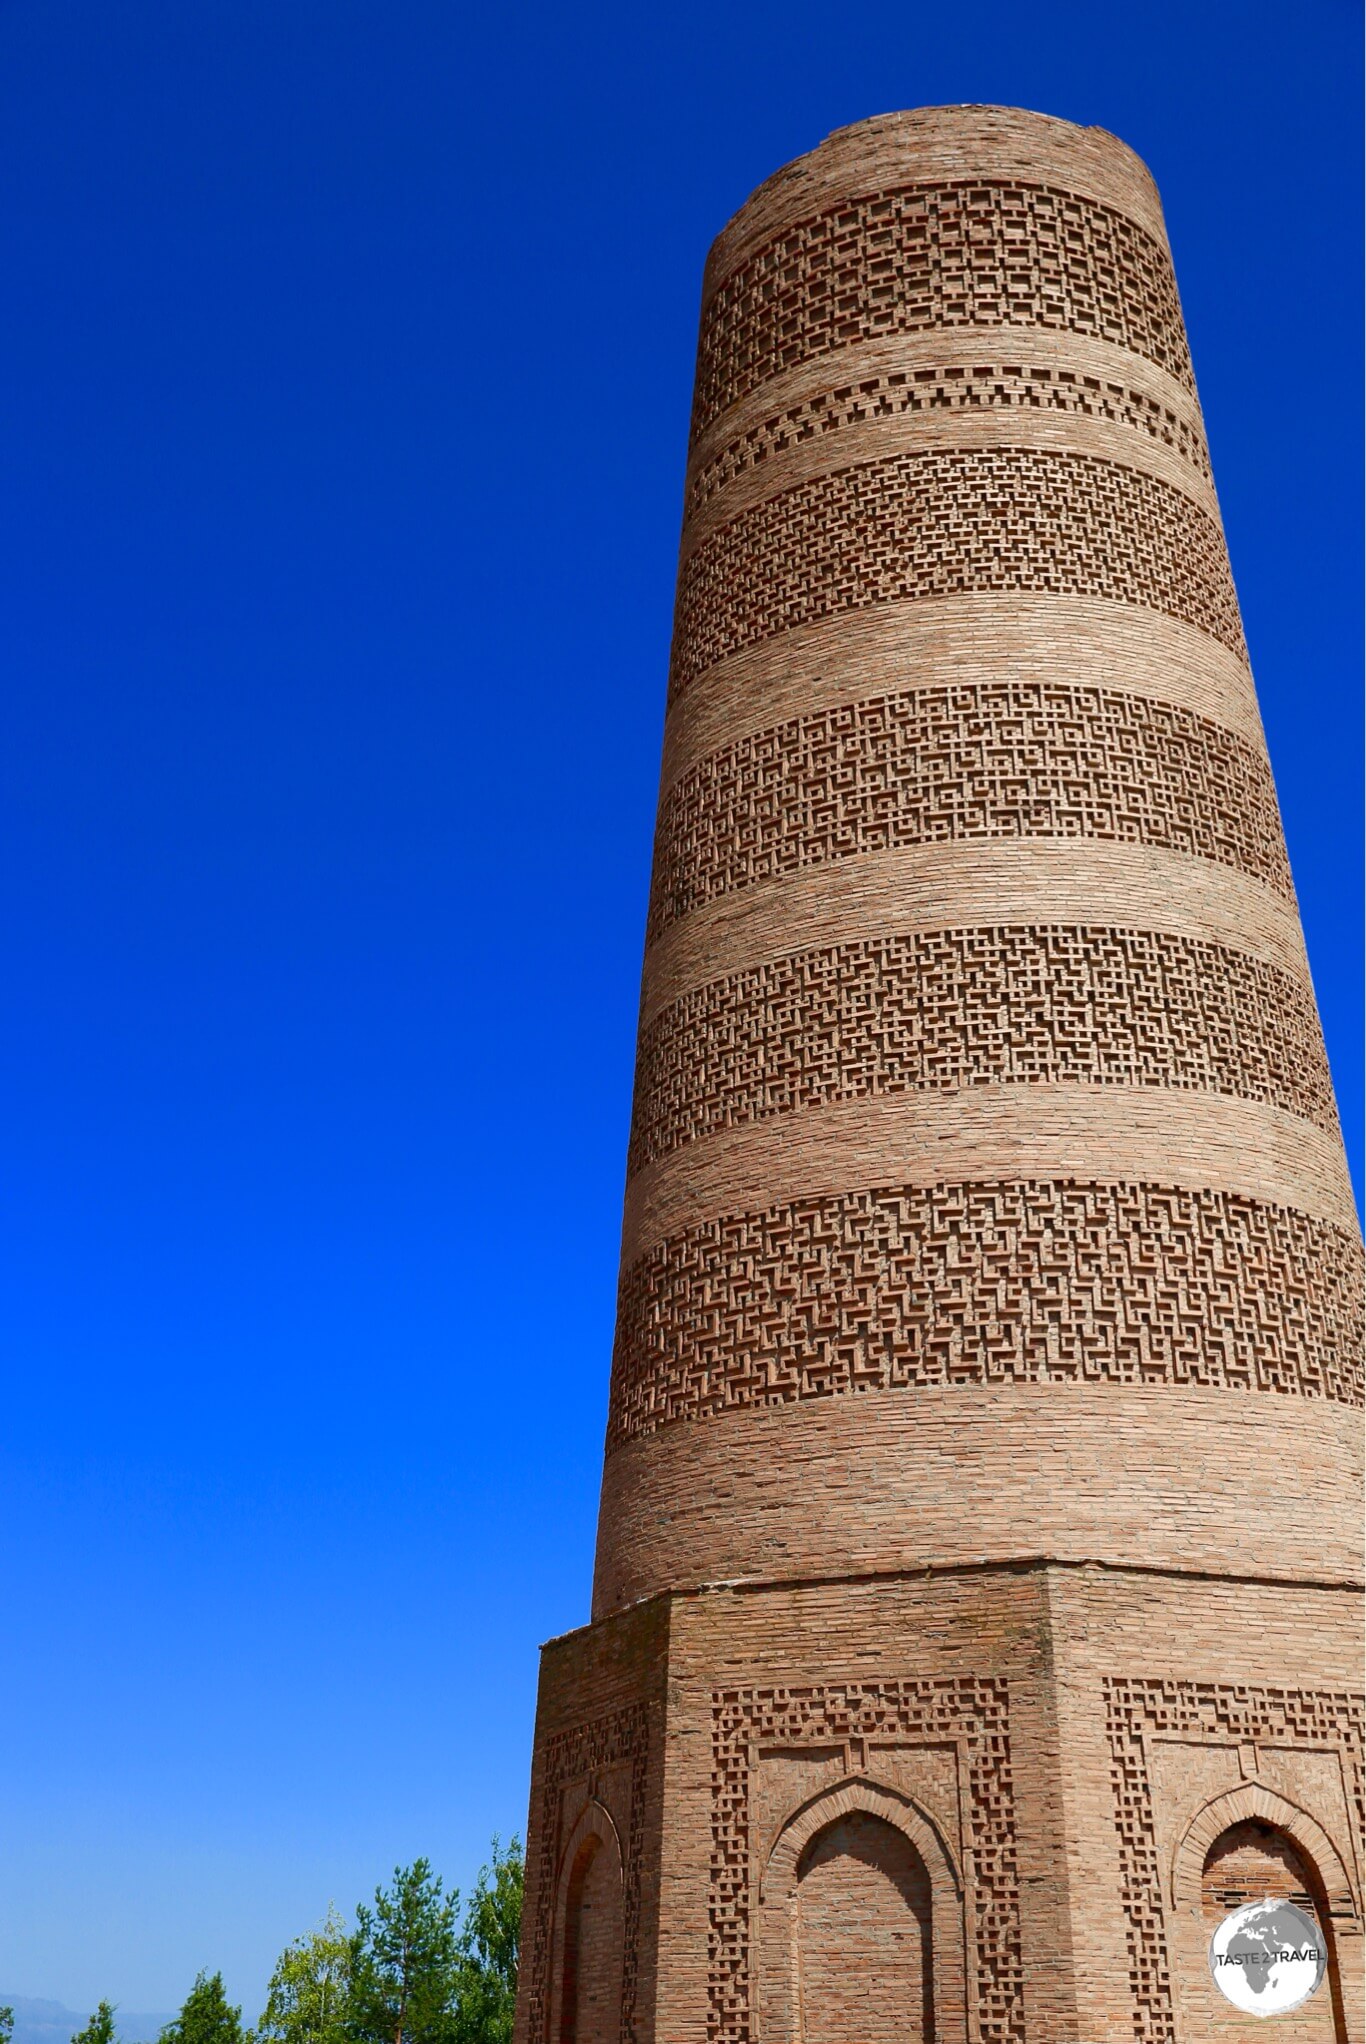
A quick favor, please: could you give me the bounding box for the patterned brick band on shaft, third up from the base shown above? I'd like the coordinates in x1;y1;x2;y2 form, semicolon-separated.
646;681;1294;942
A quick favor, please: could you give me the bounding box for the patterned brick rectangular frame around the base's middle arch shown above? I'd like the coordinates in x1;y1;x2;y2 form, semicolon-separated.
708;1676;1025;2044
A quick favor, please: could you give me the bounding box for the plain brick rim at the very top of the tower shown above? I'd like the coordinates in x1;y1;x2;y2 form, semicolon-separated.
703;102;1166;296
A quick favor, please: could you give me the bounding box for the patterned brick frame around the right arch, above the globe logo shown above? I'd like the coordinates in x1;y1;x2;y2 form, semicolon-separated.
1104;1676;1366;2044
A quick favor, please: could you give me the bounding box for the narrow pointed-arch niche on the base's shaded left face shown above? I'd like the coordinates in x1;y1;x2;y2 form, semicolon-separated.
550;1797;626;2044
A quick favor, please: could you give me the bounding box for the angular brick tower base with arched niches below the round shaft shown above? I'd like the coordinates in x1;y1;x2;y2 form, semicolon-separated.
515;1560;1366;2044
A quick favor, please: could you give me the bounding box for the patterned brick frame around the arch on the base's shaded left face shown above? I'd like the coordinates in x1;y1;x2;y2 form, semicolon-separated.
521;1703;650;2044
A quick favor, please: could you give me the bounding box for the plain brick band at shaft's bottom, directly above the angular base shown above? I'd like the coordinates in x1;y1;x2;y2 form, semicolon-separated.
595;1365;1362;1611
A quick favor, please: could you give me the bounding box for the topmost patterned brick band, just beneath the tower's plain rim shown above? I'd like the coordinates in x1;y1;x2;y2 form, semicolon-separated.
693;178;1194;437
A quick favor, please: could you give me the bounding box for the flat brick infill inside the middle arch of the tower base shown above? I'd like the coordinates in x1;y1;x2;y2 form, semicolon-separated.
795;1809;935;2044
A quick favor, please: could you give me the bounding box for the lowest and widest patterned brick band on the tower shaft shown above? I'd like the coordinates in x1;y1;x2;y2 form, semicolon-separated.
607;1181;1362;1447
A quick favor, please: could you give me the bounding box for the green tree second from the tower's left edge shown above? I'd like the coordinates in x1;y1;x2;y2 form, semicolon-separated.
349;1860;460;2044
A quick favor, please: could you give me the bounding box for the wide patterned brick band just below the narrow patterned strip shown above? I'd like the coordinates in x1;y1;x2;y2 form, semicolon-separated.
671;448;1245;699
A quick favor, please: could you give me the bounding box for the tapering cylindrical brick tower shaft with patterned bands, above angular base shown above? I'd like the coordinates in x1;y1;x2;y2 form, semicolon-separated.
595;108;1360;1613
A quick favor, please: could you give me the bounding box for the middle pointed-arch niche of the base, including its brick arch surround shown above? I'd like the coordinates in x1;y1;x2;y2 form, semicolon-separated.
757;1776;967;2044
